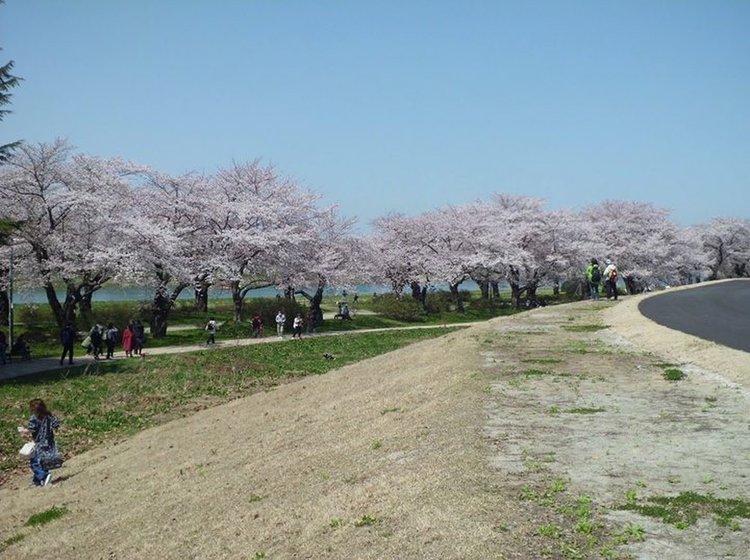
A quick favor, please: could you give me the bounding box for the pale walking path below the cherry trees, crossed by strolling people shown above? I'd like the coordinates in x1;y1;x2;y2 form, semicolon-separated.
0;321;484;381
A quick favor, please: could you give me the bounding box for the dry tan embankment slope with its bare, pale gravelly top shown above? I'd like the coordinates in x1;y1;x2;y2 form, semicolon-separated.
0;294;750;560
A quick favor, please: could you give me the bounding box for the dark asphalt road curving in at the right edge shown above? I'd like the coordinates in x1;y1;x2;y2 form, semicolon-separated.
638;280;750;352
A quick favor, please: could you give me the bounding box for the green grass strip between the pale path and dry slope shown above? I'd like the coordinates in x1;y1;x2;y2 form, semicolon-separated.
0;328;453;484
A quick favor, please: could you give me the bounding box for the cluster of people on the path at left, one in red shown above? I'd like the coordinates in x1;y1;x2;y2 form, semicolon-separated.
60;319;146;365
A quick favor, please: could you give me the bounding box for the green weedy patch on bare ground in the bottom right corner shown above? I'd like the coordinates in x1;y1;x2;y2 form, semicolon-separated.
617;492;750;529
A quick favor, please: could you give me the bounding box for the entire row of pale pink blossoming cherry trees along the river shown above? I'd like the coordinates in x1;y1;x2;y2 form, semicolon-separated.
0;141;750;336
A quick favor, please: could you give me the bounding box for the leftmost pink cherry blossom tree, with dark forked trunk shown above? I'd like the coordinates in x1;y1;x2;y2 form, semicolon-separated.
0;140;148;326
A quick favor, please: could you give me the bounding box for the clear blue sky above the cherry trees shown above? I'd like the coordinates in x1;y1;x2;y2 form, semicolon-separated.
0;0;750;225
